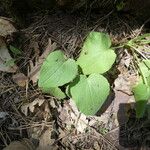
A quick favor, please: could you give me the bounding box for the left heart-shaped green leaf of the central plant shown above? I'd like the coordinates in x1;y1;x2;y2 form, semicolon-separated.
38;51;78;88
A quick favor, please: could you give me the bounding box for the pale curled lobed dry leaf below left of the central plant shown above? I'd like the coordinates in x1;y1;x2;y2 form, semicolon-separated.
21;98;45;116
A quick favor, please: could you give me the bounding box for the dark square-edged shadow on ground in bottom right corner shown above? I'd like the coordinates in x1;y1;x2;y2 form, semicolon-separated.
117;103;150;150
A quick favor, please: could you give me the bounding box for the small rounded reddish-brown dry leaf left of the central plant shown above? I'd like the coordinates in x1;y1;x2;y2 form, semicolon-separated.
12;73;28;87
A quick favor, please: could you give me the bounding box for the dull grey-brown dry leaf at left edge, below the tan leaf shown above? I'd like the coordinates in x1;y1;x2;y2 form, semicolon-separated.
0;37;18;73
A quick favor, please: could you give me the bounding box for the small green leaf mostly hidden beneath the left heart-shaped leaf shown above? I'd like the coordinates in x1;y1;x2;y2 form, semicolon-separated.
42;87;66;99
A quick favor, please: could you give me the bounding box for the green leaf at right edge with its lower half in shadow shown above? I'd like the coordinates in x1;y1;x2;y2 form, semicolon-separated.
132;83;150;118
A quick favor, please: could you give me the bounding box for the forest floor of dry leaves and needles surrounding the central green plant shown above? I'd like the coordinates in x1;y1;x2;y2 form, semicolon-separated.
0;10;150;150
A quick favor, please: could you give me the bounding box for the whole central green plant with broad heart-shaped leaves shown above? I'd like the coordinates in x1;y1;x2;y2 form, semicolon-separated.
38;32;116;115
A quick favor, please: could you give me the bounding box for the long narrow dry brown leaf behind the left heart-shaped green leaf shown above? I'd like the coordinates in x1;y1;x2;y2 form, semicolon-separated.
28;39;57;83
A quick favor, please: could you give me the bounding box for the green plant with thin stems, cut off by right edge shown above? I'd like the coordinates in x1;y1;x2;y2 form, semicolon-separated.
125;33;150;118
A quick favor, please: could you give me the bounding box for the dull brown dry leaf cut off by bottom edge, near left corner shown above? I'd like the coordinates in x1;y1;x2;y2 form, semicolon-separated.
3;139;35;150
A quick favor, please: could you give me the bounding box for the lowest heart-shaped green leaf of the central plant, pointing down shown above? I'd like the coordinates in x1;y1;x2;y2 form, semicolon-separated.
69;74;110;115
